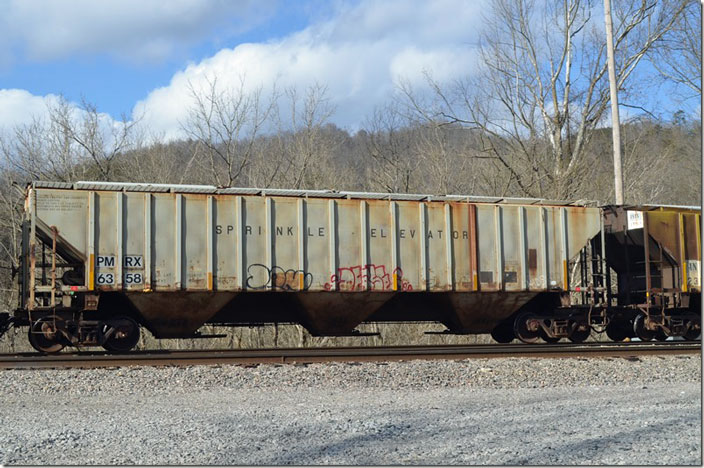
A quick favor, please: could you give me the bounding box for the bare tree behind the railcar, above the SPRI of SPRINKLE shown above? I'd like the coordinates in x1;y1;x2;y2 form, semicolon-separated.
182;77;276;187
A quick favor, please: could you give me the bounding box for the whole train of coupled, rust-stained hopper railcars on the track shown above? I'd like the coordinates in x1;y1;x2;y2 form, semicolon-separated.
0;182;701;352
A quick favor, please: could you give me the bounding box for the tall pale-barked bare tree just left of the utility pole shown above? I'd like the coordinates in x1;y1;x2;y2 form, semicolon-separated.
401;0;684;198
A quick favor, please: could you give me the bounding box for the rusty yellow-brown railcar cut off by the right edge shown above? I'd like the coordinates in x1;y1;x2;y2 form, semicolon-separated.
603;205;702;341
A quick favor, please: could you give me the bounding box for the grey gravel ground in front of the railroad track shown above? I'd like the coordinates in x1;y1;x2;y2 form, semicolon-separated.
0;355;702;465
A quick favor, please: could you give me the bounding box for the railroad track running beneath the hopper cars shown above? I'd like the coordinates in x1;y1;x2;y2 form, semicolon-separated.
0;341;702;369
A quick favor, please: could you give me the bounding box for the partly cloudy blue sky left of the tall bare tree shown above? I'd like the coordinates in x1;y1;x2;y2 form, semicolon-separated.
0;0;696;138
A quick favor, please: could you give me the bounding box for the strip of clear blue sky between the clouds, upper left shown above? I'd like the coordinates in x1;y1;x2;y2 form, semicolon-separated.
0;0;331;117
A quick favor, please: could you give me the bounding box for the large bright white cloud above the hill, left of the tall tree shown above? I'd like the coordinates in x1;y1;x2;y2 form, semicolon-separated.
135;0;483;136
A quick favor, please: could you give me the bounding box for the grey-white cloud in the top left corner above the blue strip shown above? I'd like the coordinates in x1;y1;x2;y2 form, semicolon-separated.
0;0;273;65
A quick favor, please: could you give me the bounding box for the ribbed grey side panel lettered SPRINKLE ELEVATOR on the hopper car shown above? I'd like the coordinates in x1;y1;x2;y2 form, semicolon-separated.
30;189;600;292
